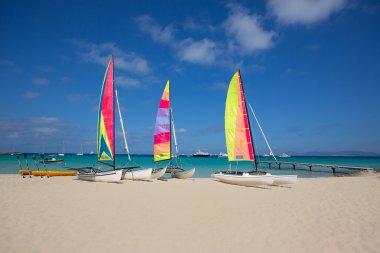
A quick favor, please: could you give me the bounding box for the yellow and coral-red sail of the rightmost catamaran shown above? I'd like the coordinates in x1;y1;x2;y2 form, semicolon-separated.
224;71;255;161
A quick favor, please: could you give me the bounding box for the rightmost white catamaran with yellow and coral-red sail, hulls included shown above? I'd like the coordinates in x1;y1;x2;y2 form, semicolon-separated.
211;71;297;186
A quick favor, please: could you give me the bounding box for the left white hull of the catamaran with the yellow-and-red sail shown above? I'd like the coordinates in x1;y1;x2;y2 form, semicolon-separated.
211;173;274;186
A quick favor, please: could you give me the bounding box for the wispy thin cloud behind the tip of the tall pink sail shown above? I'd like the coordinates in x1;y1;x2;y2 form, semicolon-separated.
70;39;151;74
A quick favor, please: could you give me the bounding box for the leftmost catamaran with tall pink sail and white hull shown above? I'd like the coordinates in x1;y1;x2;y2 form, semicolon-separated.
72;56;122;182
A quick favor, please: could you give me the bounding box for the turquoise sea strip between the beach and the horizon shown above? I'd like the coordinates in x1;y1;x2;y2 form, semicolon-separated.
0;154;380;178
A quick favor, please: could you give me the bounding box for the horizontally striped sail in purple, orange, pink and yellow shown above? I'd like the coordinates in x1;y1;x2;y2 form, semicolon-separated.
153;80;171;162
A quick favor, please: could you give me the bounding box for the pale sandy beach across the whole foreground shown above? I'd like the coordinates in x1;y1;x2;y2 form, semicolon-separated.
0;174;380;253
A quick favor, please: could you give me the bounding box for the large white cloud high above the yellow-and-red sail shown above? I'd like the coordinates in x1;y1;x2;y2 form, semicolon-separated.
223;4;276;54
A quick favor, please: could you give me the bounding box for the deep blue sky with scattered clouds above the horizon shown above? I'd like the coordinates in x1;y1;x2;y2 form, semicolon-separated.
0;0;380;154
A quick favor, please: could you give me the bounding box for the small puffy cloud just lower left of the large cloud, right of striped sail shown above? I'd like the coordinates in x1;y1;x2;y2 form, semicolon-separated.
178;39;219;64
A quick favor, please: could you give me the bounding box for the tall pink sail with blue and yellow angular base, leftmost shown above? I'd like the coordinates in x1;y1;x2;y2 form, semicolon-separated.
98;56;115;161
